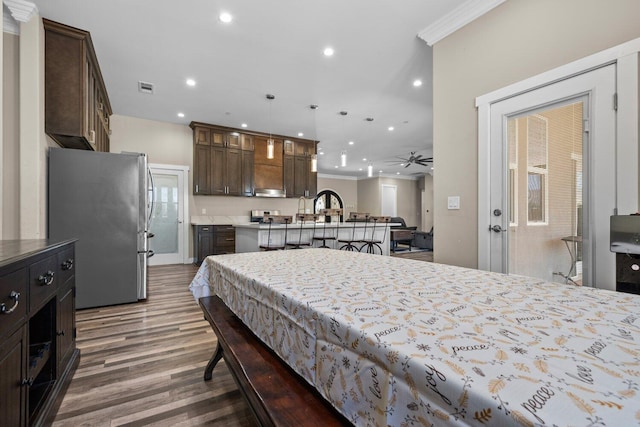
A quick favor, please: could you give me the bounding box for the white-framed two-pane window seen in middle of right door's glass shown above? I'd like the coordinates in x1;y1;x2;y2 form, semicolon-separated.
527;114;549;224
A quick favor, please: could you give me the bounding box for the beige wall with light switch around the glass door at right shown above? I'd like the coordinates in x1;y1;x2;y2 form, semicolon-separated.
433;0;640;267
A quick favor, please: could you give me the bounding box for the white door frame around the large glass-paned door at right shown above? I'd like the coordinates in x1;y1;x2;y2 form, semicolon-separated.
476;38;640;286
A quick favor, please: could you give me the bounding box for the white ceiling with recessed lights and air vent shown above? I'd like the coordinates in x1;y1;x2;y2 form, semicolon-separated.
25;0;477;177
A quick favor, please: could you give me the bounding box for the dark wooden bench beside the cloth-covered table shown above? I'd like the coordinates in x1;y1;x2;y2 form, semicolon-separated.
199;296;351;427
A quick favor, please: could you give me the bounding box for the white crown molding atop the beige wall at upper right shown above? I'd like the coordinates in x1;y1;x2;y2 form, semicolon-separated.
418;0;506;46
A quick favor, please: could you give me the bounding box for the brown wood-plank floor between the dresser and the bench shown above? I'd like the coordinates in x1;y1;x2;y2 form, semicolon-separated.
53;265;255;426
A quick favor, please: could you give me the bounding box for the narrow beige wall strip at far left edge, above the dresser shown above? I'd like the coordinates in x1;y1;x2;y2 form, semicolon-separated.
0;33;20;240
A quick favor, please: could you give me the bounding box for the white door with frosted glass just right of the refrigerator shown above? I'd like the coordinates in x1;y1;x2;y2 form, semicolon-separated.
149;164;189;265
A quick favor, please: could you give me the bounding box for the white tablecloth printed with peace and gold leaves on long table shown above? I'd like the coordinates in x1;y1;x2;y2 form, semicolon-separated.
190;249;640;427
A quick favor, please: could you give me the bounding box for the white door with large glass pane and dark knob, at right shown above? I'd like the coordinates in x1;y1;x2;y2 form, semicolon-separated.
488;65;616;287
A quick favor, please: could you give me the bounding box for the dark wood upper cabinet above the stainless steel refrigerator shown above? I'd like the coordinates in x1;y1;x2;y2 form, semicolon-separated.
42;19;112;152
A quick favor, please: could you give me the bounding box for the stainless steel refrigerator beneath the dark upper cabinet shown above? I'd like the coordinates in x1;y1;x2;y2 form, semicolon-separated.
48;148;151;308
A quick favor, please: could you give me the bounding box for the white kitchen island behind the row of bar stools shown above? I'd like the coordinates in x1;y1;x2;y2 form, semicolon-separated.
234;222;398;255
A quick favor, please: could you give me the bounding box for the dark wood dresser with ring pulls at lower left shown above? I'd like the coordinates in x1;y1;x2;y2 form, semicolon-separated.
0;240;80;426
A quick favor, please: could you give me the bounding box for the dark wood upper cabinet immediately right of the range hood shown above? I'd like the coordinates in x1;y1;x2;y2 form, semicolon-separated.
284;141;318;198
